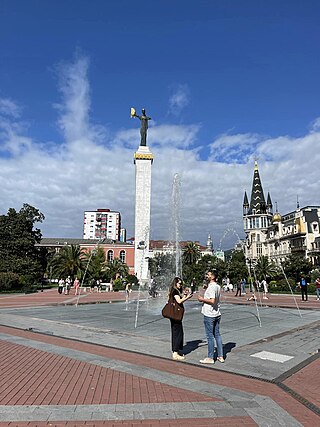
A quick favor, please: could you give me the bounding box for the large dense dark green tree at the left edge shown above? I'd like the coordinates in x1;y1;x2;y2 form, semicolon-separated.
0;204;45;285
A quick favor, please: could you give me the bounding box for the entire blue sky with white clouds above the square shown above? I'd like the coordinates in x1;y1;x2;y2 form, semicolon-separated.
0;0;320;247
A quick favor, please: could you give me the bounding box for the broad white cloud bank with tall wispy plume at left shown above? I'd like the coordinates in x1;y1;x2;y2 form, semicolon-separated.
0;57;320;248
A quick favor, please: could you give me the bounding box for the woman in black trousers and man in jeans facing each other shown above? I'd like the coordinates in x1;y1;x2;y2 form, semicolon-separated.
169;271;224;364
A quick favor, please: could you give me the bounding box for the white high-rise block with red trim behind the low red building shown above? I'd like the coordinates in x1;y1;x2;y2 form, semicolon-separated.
83;209;121;241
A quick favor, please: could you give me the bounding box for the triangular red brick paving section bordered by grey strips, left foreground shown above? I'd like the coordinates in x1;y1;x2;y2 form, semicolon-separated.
0;340;220;405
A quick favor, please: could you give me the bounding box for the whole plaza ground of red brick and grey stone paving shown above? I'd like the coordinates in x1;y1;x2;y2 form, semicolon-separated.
0;290;320;427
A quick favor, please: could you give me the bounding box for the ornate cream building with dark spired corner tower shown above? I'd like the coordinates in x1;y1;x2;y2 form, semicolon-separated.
243;163;320;266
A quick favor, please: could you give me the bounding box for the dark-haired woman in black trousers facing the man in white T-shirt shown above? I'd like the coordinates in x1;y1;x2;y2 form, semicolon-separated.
169;277;192;360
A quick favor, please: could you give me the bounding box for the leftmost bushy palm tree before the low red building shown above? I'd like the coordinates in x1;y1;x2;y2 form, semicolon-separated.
50;245;84;279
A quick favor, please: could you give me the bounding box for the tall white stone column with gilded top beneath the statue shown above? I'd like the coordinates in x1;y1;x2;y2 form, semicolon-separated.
134;146;153;284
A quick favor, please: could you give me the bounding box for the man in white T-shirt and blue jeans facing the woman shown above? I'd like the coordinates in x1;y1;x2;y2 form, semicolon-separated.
198;271;225;364
